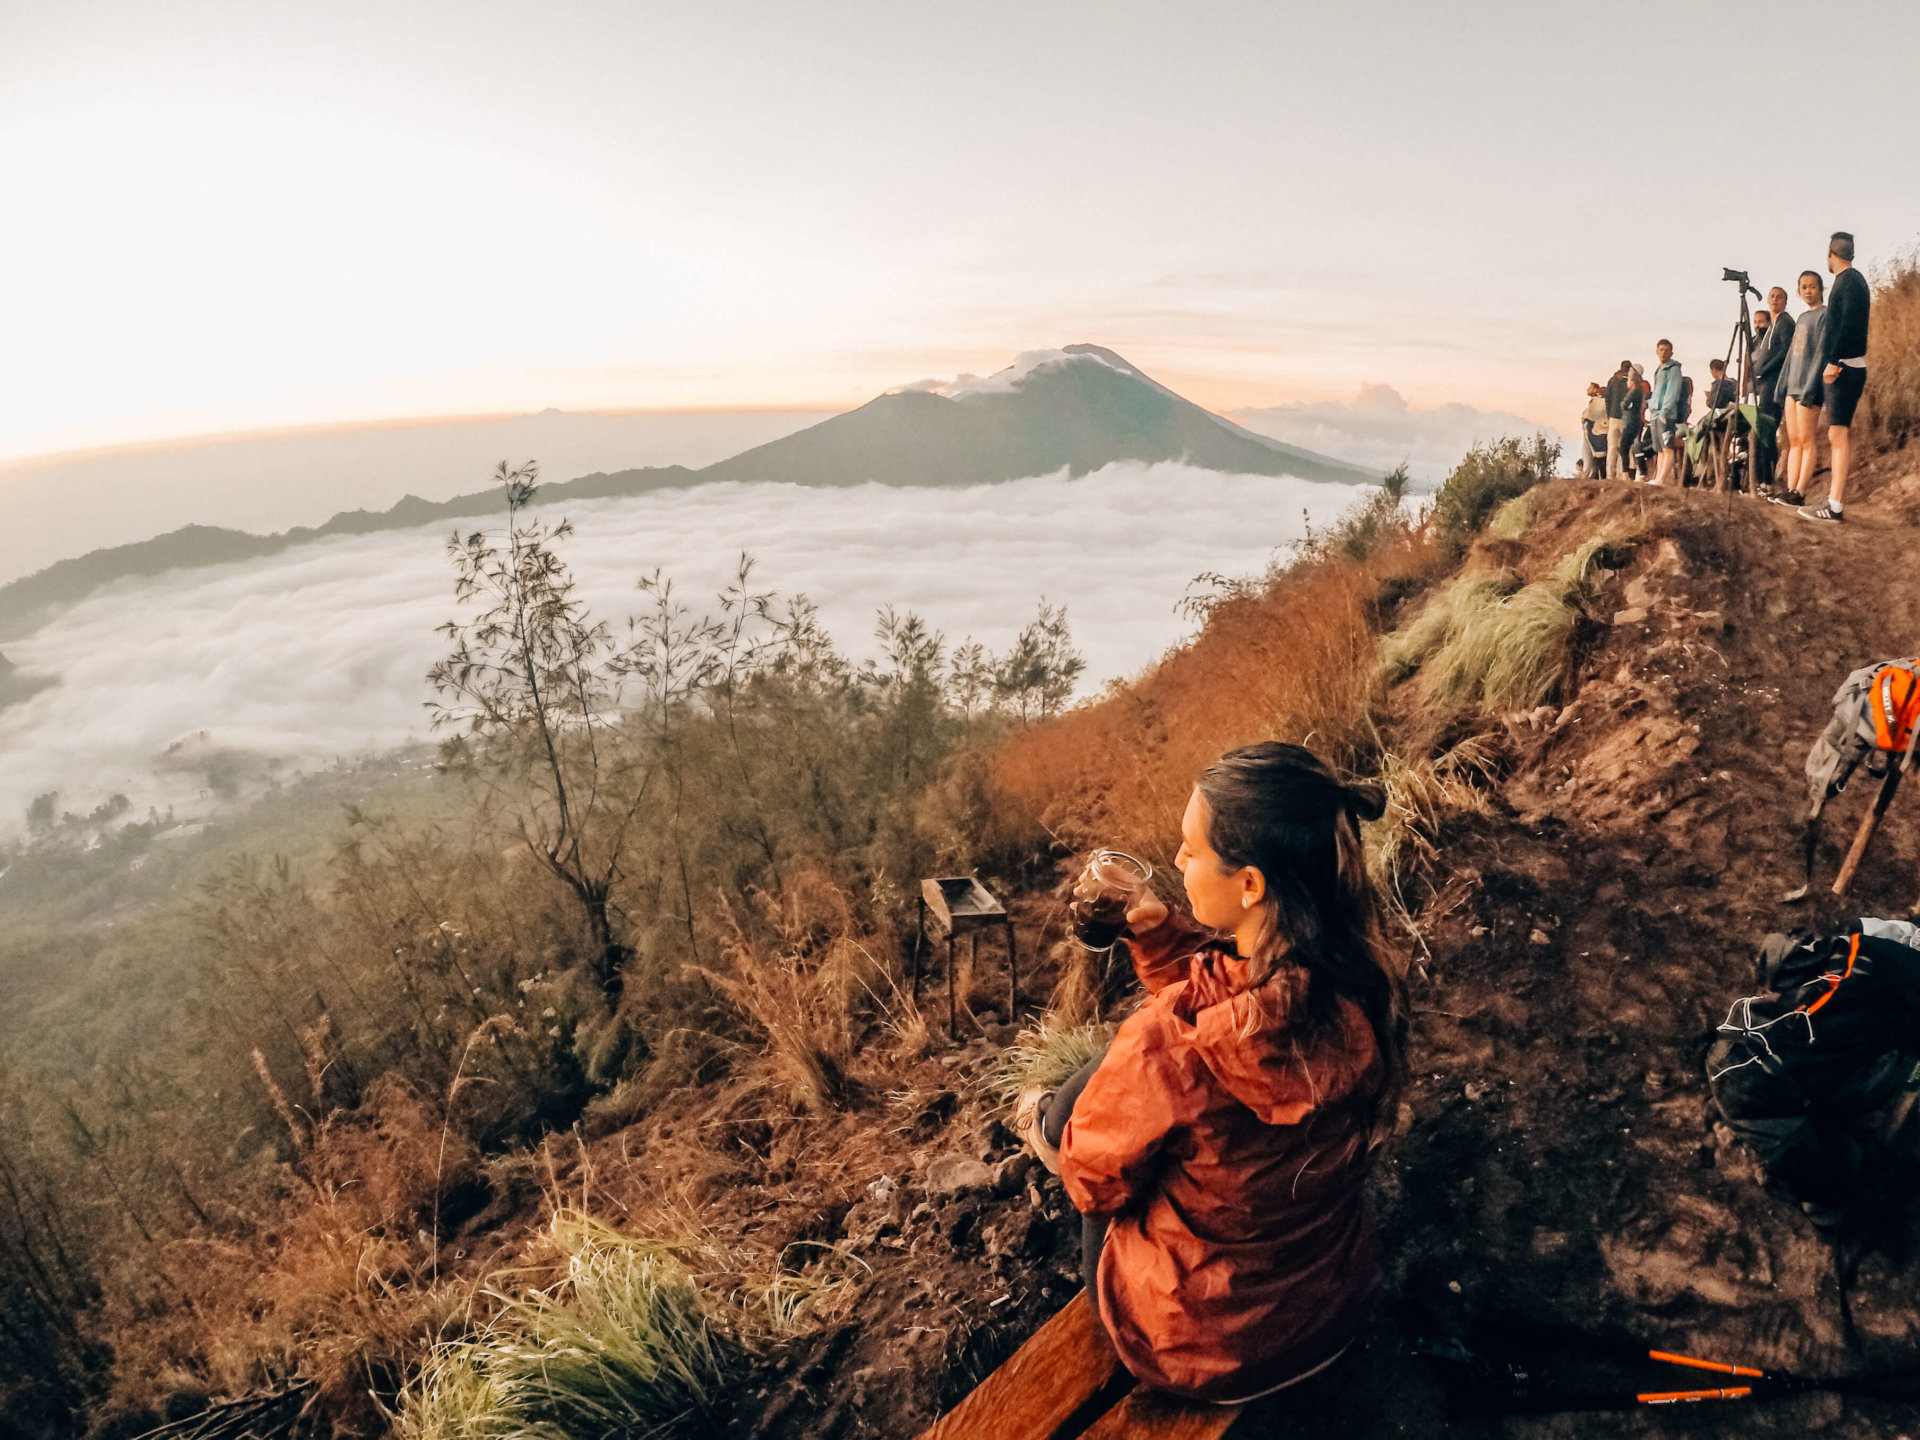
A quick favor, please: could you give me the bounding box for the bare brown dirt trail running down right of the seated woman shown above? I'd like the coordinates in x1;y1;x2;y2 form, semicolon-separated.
1351;464;1920;1436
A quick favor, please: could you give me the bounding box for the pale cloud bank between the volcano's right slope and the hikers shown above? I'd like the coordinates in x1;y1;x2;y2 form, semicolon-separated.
1231;384;1584;486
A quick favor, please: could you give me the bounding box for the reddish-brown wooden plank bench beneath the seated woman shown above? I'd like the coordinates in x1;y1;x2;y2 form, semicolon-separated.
920;1292;1240;1440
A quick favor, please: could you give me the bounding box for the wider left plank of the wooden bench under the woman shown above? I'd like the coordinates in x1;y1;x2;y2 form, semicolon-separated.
920;1292;1133;1440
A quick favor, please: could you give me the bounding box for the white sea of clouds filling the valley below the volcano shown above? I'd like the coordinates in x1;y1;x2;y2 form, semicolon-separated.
0;463;1359;833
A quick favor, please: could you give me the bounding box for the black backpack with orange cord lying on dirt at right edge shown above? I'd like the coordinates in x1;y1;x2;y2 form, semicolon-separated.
1707;916;1920;1229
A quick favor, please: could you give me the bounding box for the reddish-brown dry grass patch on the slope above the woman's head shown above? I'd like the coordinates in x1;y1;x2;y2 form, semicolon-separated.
996;532;1434;866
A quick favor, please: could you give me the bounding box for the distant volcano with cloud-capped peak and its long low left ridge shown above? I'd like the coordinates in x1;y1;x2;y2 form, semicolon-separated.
0;346;1379;639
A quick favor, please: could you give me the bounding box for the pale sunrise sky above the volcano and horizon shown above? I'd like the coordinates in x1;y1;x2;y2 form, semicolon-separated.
0;0;1920;459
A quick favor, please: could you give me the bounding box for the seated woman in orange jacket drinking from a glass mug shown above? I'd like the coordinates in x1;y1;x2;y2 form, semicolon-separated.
1018;741;1405;1404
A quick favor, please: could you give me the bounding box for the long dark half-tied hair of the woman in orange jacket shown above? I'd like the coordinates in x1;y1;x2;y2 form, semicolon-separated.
1198;739;1407;1092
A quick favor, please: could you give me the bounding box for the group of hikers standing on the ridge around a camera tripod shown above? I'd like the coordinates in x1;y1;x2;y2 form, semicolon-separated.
1580;230;1872;524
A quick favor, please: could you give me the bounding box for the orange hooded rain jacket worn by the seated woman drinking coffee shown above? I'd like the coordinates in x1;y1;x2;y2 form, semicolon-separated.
1060;916;1384;1400
